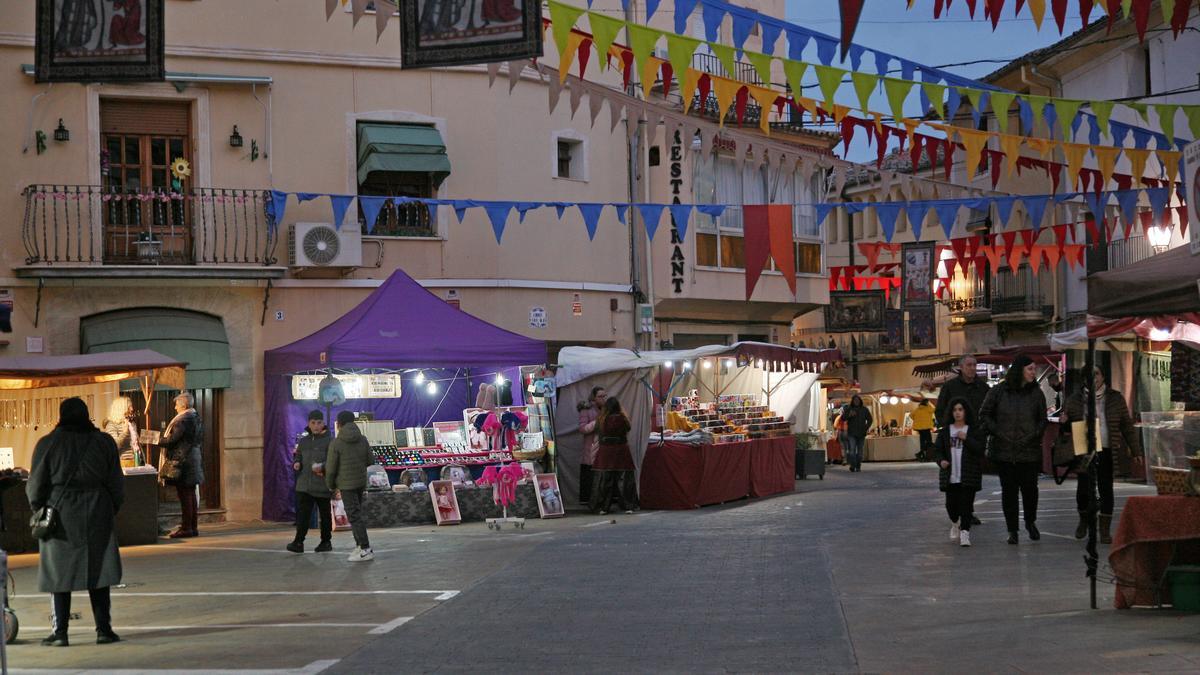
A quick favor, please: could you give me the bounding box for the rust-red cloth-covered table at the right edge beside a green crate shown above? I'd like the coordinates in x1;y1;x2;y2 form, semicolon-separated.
1109;495;1200;609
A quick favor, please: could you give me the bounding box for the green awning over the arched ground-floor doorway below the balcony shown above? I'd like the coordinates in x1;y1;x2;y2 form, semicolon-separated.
79;307;233;389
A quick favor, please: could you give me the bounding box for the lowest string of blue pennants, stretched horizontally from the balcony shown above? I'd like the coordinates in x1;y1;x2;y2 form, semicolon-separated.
258;182;1187;244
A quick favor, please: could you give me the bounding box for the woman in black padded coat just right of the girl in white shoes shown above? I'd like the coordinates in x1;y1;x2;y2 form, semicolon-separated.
979;354;1046;544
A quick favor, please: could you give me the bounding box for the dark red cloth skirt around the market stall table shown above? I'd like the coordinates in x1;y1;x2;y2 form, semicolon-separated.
640;436;796;509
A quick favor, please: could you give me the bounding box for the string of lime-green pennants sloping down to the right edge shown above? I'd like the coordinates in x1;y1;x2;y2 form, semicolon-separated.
548;0;1200;150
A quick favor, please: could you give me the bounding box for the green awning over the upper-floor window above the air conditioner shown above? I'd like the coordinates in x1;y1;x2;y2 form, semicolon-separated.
359;123;450;187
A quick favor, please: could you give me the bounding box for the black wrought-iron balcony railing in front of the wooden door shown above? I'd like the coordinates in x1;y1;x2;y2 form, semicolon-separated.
22;185;277;265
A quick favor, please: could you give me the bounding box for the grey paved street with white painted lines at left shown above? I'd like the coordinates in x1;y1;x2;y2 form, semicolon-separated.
10;465;1200;673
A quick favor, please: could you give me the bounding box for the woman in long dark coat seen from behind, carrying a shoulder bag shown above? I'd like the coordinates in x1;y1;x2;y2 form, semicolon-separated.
25;399;125;647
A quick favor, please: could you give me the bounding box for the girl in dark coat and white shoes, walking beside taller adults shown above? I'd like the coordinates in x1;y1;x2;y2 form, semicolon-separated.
934;398;988;546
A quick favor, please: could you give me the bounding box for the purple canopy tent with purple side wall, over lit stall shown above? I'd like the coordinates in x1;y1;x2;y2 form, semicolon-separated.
263;269;546;520
